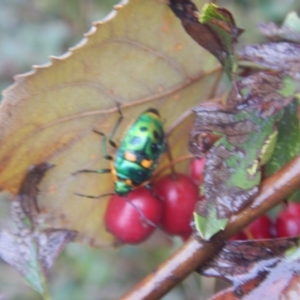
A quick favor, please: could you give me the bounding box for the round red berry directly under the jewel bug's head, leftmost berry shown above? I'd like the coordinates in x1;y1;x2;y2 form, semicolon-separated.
105;187;162;244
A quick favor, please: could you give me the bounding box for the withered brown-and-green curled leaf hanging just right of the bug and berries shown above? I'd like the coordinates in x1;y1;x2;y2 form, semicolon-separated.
190;103;282;219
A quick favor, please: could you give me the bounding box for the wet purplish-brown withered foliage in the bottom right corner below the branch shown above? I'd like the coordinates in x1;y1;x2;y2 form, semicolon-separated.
198;238;300;300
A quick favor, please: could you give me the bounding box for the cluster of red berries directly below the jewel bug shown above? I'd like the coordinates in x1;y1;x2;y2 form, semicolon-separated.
105;160;204;244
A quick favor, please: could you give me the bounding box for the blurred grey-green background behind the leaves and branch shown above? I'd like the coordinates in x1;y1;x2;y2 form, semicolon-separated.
0;0;300;300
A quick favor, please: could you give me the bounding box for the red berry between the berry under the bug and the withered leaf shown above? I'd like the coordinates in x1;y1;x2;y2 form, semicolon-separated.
153;174;198;237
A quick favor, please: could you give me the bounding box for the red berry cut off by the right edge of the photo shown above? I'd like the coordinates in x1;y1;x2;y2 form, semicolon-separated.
275;202;300;237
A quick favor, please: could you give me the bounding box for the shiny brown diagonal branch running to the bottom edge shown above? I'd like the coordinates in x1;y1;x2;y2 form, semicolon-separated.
121;156;300;300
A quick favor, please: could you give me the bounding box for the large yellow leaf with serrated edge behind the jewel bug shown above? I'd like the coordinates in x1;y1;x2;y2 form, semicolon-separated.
0;0;219;246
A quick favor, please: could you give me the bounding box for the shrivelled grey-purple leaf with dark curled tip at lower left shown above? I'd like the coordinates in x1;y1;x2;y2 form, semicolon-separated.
0;163;76;299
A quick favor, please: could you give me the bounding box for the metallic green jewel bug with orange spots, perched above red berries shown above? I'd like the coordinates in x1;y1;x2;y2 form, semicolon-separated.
76;108;165;198
